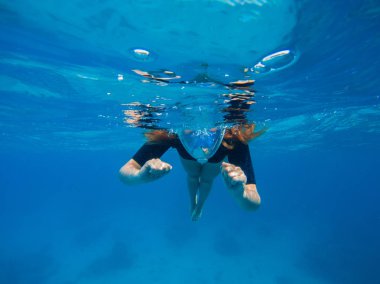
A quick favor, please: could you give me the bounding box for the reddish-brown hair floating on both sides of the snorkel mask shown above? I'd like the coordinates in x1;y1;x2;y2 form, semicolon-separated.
144;123;267;149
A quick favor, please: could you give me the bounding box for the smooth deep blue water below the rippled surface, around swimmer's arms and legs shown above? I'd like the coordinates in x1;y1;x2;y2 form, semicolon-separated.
0;144;380;283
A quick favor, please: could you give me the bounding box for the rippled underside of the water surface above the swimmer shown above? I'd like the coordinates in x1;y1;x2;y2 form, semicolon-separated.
0;1;380;152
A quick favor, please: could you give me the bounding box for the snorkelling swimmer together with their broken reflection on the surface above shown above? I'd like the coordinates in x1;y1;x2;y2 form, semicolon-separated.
120;67;266;221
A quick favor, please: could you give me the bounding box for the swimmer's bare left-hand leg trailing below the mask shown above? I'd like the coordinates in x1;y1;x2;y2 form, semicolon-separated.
181;158;202;213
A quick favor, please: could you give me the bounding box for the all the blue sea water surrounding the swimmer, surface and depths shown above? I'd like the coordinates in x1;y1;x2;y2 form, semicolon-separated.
0;0;380;284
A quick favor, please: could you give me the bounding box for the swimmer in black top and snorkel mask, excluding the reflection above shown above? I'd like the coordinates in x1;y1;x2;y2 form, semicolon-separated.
120;124;265;221
